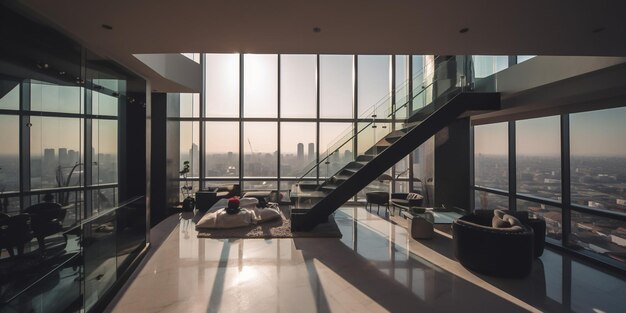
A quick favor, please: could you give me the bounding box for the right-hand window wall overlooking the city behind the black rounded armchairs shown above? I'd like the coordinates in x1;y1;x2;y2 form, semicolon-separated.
473;107;626;267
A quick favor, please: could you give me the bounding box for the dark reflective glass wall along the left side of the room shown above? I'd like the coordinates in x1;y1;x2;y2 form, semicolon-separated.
0;5;147;312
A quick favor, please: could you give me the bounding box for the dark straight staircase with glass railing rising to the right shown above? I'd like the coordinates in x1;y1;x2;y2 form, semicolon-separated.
291;55;500;231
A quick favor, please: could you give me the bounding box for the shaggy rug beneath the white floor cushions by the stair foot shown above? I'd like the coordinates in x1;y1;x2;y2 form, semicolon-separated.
197;213;341;239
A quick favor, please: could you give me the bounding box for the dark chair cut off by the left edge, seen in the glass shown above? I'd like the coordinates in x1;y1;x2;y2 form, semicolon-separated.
0;214;33;257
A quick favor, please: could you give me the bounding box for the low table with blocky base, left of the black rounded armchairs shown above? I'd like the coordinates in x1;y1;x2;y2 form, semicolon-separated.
401;207;465;239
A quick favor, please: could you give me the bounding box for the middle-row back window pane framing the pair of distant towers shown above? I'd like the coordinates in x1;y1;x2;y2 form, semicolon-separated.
280;123;316;178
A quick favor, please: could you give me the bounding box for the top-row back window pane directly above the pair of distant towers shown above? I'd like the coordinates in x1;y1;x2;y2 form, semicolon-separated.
280;55;317;118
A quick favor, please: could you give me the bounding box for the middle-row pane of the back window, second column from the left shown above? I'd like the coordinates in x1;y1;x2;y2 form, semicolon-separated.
204;122;239;177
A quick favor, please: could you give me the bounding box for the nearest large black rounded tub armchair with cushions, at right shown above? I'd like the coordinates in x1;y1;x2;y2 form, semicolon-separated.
452;214;534;278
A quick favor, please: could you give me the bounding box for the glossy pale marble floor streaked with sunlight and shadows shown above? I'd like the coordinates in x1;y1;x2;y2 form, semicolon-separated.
107;207;626;312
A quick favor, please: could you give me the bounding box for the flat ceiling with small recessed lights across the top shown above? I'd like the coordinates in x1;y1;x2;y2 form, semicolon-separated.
17;0;626;91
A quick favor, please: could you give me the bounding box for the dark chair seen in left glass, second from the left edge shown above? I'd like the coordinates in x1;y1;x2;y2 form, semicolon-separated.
24;202;67;251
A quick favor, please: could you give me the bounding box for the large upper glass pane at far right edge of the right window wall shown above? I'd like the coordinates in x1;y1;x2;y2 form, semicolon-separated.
570;108;626;212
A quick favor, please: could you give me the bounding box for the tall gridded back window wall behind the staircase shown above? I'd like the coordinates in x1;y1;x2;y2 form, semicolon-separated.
169;54;433;197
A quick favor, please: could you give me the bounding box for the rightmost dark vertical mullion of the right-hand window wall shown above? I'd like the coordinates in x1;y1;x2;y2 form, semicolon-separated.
561;114;572;247
